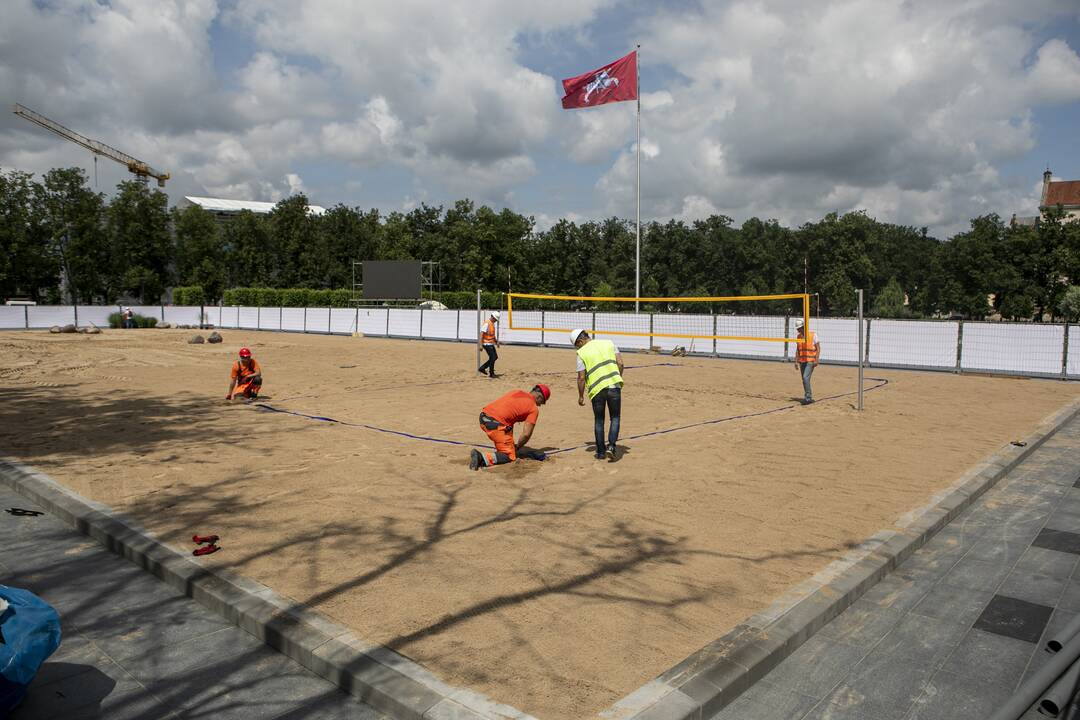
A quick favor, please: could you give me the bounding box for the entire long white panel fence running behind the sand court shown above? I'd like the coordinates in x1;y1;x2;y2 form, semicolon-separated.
0;305;1080;378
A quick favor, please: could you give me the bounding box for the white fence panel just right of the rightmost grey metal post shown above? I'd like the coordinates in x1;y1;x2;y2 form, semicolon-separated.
864;320;960;368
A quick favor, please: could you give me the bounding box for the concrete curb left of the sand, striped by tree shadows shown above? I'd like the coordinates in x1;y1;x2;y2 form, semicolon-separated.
0;460;536;720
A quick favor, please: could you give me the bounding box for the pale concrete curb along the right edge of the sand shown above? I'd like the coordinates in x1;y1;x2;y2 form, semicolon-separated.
599;400;1080;720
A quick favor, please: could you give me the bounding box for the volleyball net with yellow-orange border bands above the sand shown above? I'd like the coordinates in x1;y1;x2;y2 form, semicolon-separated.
507;293;810;342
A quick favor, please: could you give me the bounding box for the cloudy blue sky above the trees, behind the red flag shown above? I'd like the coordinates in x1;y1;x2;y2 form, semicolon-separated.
0;0;1080;239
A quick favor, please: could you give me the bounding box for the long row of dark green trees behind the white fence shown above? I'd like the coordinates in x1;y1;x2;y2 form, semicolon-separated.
0;168;1080;321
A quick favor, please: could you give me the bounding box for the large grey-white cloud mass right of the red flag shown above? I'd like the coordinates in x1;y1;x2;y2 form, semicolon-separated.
597;0;1080;231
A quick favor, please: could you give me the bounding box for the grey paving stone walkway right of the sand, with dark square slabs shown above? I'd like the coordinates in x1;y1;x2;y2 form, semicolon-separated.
714;420;1080;720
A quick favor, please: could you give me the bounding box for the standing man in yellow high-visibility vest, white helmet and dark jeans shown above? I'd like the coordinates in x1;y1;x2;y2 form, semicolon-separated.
570;329;623;462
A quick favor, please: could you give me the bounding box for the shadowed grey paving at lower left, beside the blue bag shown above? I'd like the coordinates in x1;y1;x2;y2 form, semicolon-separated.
0;488;382;720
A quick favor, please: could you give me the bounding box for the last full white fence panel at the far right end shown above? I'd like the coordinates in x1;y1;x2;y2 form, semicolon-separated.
960;323;1065;375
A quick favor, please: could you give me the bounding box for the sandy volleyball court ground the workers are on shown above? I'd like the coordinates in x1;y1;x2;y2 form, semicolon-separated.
0;330;1080;720
